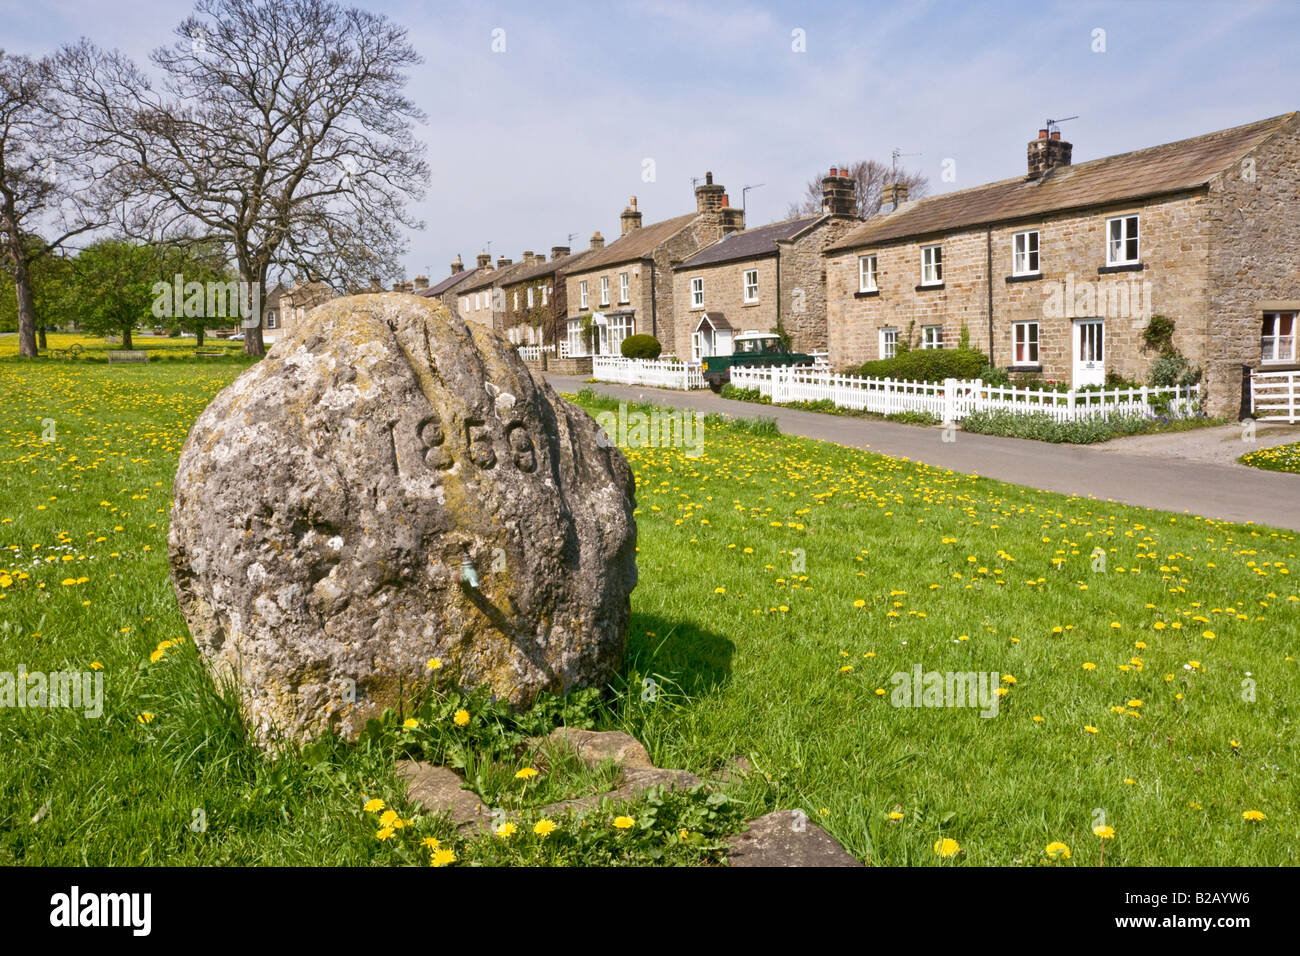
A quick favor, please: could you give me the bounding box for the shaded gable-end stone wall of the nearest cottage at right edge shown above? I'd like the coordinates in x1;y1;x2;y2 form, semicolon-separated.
1203;117;1300;416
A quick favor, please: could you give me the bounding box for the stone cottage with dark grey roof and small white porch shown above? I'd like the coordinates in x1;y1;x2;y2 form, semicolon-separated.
672;166;861;362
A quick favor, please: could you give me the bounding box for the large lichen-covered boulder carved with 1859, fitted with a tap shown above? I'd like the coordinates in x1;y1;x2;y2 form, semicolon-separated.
169;294;636;743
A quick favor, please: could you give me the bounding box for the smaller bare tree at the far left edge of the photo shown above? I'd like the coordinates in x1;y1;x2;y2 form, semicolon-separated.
0;49;96;358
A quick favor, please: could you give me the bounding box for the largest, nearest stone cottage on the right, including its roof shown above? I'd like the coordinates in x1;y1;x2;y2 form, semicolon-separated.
826;113;1300;415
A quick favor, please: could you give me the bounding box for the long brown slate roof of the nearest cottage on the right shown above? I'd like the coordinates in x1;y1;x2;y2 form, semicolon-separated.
826;112;1300;252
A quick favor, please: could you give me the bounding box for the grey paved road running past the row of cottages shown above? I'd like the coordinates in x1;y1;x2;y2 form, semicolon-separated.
547;375;1300;531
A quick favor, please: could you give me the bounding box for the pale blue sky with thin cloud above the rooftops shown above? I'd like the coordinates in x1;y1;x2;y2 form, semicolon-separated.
0;0;1300;281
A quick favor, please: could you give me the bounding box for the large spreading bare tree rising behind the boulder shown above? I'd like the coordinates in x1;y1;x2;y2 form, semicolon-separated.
57;0;429;355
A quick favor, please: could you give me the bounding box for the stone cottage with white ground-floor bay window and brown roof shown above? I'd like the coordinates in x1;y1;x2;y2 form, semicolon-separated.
564;173;745;358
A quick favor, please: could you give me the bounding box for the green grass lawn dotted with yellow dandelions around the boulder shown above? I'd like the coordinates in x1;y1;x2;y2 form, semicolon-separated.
0;359;1300;866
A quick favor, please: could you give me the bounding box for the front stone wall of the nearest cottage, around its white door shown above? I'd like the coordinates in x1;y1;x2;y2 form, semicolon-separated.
827;191;1210;382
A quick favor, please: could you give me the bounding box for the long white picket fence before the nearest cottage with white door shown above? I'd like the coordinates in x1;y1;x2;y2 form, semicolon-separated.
731;367;1200;421
